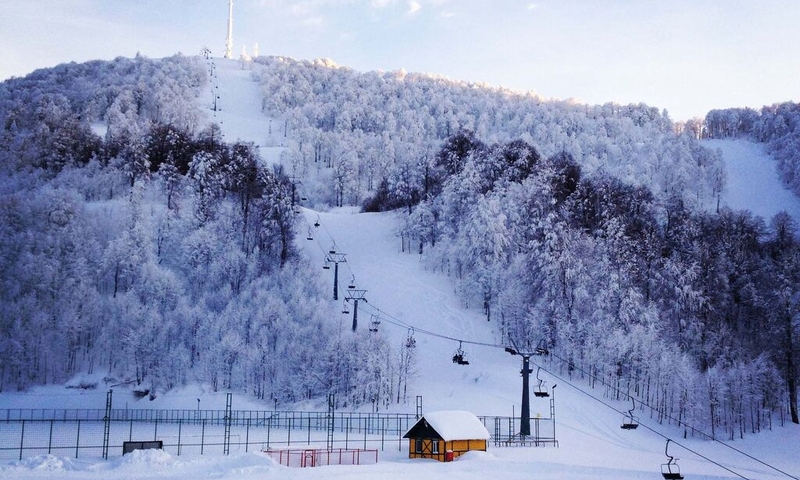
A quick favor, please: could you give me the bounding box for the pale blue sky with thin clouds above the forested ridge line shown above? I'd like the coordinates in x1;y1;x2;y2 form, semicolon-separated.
0;0;800;120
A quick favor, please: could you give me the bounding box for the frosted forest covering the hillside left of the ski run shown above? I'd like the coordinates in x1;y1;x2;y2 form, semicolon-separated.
0;56;393;405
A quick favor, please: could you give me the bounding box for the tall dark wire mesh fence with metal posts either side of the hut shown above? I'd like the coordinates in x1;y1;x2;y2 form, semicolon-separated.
0;409;557;459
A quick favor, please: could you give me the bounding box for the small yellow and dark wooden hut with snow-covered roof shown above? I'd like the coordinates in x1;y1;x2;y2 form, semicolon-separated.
403;410;489;462
